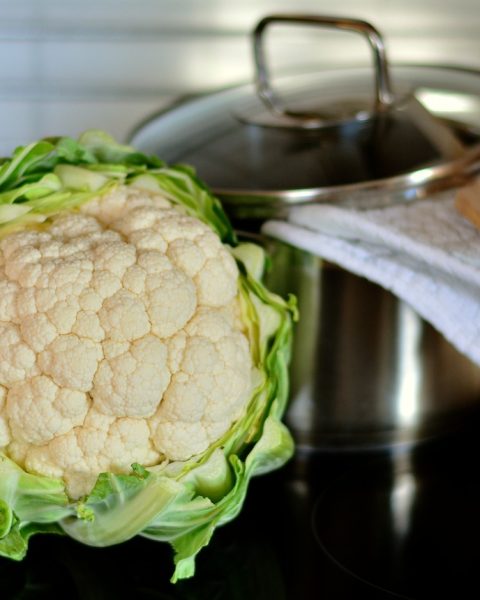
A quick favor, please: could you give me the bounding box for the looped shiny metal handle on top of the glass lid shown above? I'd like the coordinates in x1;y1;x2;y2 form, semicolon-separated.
253;14;394;121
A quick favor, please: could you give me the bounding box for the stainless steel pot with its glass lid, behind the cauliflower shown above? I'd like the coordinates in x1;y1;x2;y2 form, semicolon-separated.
131;15;480;448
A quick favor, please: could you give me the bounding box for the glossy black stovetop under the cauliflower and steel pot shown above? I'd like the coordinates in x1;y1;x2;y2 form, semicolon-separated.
0;412;480;600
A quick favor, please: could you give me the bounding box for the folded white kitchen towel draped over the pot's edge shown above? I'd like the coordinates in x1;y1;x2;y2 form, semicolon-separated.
263;192;480;365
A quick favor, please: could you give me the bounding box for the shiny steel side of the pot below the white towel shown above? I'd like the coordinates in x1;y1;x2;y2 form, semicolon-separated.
267;241;480;448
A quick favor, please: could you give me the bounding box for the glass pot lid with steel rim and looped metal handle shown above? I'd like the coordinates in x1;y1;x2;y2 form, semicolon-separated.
131;15;480;217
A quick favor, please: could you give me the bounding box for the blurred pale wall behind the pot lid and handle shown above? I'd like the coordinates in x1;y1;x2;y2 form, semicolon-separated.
0;0;480;153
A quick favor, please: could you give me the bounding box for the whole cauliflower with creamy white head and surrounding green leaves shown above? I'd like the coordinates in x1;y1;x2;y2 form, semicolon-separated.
0;132;296;580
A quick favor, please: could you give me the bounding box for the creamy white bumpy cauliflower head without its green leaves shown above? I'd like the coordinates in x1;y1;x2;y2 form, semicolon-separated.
0;185;253;498
